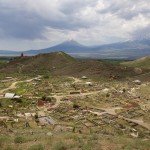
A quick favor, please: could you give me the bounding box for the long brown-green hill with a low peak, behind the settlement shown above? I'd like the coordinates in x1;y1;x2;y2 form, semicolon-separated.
0;52;138;78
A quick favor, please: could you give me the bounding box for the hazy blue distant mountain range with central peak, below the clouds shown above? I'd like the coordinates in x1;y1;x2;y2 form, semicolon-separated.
0;39;150;60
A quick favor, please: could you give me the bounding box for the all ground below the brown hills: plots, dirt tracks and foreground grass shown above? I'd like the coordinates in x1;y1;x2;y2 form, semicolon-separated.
0;55;150;150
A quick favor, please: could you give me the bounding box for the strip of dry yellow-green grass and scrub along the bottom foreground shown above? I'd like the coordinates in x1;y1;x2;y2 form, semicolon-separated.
0;129;150;150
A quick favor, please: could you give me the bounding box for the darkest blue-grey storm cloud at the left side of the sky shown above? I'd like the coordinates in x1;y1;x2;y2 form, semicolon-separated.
0;6;47;39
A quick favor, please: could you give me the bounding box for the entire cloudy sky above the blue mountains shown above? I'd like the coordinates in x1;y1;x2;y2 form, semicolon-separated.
0;0;150;50
